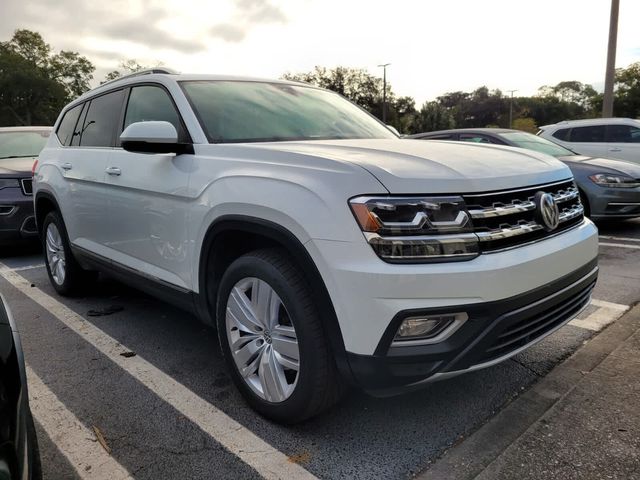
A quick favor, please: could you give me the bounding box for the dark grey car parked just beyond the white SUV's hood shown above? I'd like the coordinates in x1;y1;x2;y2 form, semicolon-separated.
405;128;640;219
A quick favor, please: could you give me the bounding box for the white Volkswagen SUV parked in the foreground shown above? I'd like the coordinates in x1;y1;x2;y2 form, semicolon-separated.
34;72;598;422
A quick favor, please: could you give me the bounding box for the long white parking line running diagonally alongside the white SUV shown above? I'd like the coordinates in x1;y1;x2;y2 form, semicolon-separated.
0;263;316;479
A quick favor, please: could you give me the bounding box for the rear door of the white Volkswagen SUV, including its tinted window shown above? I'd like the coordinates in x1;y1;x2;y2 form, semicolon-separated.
58;90;124;255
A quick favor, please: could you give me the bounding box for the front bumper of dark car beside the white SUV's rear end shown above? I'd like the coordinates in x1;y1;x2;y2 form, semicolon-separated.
0;188;38;245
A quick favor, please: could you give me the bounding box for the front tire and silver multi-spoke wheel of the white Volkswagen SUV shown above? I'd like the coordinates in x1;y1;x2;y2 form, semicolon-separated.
216;249;344;424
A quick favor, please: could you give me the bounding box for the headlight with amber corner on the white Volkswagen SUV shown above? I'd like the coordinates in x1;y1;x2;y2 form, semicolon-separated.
349;196;479;263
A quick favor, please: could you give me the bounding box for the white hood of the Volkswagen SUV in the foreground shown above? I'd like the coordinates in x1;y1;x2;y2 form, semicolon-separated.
255;139;571;194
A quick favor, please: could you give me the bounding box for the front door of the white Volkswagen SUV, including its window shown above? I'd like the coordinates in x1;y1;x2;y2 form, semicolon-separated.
106;84;193;289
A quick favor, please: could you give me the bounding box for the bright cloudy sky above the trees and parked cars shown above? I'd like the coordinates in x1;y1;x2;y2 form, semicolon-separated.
0;0;640;105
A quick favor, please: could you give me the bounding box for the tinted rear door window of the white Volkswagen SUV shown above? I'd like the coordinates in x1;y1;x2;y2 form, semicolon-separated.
80;90;124;147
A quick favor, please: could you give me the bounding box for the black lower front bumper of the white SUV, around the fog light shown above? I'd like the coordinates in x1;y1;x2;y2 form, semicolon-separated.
348;260;598;395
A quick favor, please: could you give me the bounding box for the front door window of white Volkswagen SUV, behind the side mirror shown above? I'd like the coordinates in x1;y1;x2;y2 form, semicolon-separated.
124;85;185;141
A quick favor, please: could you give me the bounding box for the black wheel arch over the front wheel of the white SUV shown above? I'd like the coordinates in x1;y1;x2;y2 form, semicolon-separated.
196;215;352;380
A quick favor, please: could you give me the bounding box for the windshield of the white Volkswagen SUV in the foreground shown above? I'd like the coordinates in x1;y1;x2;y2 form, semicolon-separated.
181;81;397;143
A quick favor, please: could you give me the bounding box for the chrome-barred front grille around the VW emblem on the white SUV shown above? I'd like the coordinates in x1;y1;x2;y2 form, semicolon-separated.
463;180;584;252
